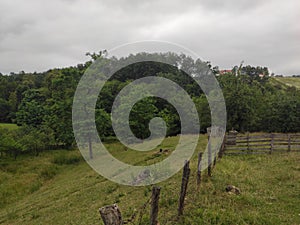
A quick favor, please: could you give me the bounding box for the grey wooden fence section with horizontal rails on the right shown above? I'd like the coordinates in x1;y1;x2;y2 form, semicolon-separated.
224;133;300;155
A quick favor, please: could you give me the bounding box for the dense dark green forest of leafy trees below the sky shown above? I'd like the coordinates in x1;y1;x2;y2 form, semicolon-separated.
0;52;300;157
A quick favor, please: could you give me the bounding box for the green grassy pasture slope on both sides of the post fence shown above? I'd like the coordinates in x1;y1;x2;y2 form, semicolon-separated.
0;136;300;225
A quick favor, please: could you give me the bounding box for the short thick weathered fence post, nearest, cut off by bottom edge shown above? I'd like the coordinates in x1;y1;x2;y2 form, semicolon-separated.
99;204;123;225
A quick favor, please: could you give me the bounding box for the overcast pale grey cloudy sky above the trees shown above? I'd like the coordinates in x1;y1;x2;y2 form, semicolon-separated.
0;0;300;75
